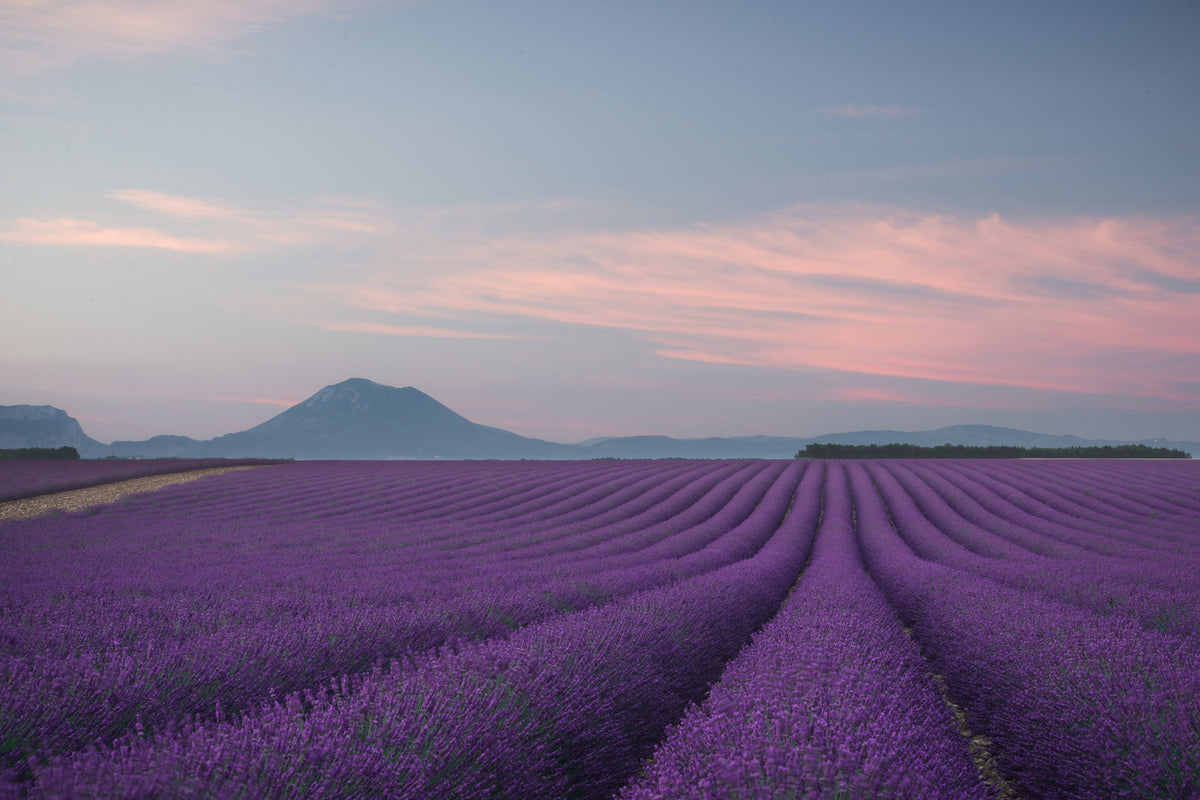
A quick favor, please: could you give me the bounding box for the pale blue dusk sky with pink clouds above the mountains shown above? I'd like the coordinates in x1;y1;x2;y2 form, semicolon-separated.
0;0;1200;441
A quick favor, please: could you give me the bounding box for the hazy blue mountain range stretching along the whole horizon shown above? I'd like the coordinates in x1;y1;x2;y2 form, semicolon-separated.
0;378;1200;459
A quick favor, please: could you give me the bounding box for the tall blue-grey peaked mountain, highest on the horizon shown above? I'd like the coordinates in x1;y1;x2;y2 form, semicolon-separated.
204;378;574;459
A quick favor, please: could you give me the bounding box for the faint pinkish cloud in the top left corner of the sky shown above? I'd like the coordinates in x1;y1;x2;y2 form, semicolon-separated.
0;0;369;74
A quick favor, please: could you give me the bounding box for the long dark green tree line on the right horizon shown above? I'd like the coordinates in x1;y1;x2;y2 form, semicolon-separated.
796;443;1192;458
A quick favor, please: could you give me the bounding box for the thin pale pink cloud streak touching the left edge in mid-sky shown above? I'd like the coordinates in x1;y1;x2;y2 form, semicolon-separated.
0;217;245;255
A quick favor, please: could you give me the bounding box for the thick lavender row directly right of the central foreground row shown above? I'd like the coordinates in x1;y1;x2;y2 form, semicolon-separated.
847;465;1200;799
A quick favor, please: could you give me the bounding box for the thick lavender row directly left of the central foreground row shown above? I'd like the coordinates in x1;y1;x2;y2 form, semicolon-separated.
29;462;820;799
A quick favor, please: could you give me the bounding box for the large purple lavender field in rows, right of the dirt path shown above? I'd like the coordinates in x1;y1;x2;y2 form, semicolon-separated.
0;461;1200;800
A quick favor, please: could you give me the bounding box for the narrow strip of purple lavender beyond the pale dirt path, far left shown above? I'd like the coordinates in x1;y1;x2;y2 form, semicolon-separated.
0;458;288;503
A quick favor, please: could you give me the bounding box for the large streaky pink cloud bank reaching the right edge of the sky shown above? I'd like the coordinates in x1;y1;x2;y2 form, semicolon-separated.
311;206;1200;404
